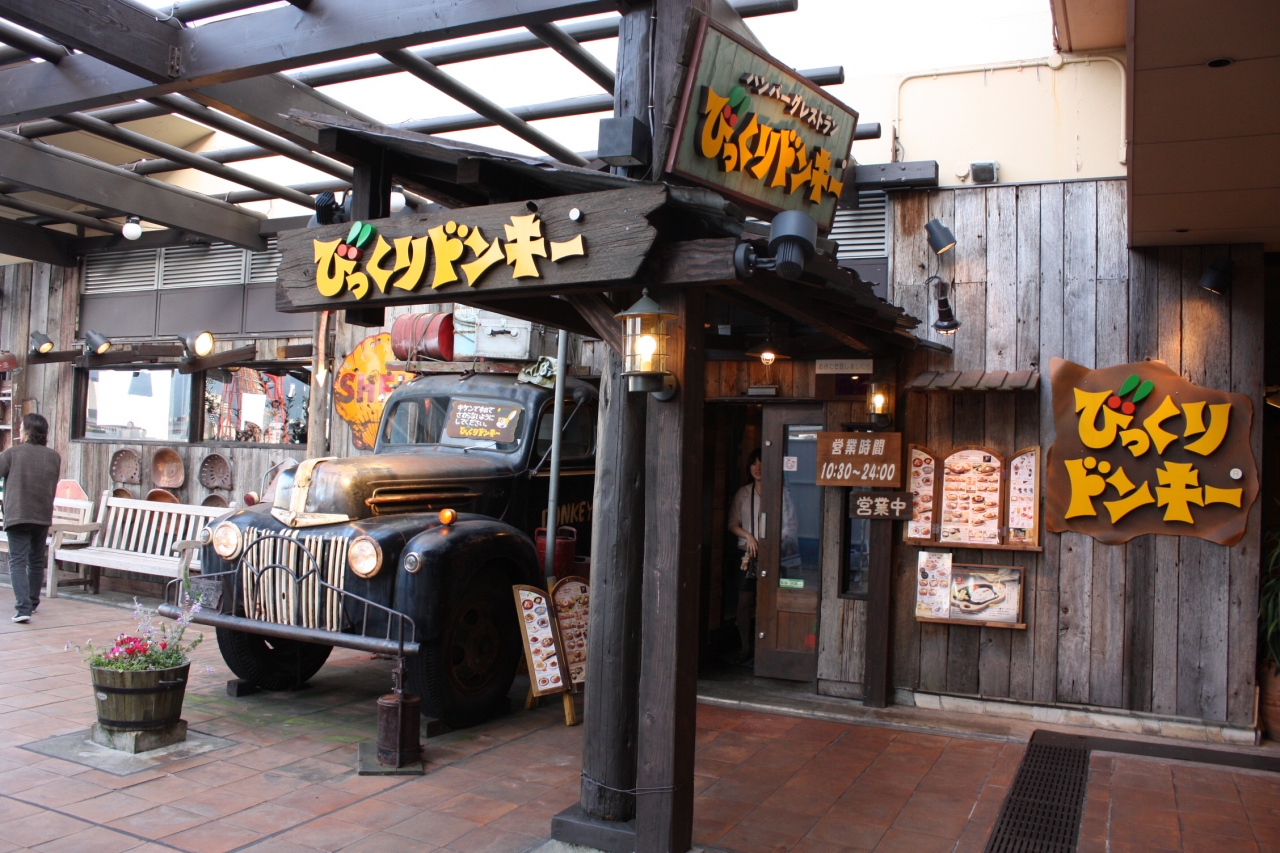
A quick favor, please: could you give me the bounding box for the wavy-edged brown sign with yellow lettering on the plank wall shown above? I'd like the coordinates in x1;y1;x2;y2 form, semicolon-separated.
1044;359;1258;546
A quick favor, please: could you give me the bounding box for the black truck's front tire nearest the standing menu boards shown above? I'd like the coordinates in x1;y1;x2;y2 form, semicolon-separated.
406;566;521;729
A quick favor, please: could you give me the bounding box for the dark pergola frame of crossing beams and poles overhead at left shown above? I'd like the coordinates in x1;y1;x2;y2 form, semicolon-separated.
0;0;808;263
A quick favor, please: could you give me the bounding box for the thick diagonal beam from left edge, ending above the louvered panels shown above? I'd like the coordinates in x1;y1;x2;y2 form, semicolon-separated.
0;131;266;251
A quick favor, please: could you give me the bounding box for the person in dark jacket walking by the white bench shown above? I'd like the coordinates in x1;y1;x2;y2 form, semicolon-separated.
0;414;61;622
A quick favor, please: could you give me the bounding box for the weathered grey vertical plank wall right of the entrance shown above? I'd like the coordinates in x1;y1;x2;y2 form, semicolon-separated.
875;175;1263;725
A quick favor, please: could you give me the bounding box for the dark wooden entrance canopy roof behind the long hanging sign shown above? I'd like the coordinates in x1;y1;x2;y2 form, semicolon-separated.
276;111;940;353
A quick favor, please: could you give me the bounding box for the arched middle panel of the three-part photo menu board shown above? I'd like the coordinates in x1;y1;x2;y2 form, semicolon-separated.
938;447;1005;547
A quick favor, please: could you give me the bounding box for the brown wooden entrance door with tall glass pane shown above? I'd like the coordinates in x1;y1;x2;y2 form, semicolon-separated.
755;406;823;681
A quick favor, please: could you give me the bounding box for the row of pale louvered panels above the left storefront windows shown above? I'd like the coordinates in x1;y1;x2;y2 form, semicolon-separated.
84;240;280;293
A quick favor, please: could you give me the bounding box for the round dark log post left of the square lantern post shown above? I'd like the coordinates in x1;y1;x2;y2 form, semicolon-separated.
581;348;648;821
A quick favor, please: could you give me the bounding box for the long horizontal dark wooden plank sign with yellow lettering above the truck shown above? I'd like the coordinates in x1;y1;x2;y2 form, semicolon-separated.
275;186;667;311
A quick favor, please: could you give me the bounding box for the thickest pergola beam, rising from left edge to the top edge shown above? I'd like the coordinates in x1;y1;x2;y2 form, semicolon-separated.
0;0;614;124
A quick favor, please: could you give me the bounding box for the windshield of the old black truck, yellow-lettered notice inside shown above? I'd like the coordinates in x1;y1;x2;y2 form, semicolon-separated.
383;397;525;453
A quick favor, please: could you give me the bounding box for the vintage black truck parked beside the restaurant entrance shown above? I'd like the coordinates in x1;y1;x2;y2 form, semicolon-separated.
161;374;596;727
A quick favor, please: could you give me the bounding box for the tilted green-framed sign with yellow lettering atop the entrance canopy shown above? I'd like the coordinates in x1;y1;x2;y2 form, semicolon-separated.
666;18;858;229
